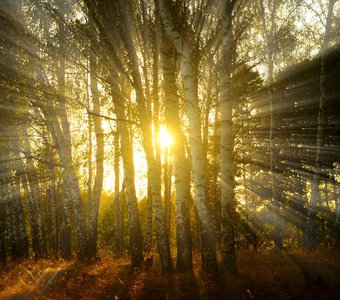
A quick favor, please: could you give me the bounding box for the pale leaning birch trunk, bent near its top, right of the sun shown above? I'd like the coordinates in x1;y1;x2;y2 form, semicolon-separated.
158;0;217;272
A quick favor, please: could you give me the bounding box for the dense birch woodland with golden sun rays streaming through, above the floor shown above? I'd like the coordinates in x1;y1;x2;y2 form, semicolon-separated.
0;0;340;299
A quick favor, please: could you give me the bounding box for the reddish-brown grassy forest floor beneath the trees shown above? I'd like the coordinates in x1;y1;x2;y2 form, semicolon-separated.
0;251;340;300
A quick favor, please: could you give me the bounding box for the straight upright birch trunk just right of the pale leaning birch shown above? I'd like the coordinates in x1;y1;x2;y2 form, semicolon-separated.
219;1;236;273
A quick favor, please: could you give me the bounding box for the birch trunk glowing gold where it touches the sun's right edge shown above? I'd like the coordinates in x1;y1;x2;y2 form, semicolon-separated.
162;37;192;272
